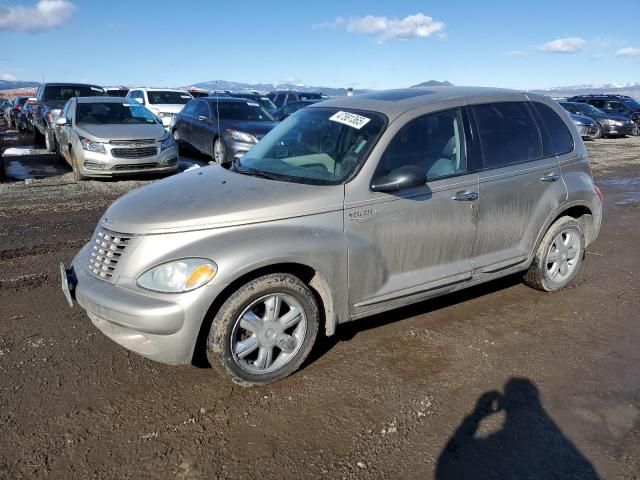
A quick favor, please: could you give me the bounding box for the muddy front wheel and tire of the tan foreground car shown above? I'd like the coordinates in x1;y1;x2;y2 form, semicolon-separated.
206;274;320;387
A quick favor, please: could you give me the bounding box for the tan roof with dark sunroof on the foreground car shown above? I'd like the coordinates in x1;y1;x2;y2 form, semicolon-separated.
309;87;524;120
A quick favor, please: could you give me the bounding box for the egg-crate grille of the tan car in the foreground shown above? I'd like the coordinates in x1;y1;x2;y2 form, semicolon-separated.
88;227;137;283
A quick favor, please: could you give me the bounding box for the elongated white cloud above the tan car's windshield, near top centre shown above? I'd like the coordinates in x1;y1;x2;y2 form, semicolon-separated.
313;13;445;43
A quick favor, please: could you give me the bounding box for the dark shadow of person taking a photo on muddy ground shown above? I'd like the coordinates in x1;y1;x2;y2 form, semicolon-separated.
435;378;599;480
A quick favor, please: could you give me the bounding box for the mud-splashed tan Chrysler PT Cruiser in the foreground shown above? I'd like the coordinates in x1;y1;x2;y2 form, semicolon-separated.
61;87;602;385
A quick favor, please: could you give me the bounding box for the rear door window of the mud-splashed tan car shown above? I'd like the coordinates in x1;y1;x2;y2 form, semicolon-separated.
473;102;542;168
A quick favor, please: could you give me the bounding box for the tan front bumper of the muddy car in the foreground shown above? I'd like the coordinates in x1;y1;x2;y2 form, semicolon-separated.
70;245;222;365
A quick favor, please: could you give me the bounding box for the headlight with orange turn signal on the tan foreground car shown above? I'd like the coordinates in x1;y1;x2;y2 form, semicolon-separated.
137;258;217;293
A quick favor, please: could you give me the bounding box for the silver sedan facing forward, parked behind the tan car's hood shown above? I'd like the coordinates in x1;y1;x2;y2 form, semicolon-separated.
55;97;178;180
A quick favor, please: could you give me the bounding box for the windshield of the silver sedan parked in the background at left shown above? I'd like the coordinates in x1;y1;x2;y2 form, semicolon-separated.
76;101;158;125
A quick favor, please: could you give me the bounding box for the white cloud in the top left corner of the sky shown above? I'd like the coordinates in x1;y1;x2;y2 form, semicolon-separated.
0;0;76;32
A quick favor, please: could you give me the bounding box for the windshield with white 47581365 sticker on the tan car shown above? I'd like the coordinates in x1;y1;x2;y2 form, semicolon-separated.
237;108;387;185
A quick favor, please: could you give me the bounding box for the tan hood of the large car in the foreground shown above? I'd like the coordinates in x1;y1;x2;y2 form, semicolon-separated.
100;165;344;234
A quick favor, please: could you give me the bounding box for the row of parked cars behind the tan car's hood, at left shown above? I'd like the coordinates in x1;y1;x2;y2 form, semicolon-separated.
5;83;327;180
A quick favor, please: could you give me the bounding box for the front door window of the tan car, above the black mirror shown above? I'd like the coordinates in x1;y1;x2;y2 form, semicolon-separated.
374;109;466;180
